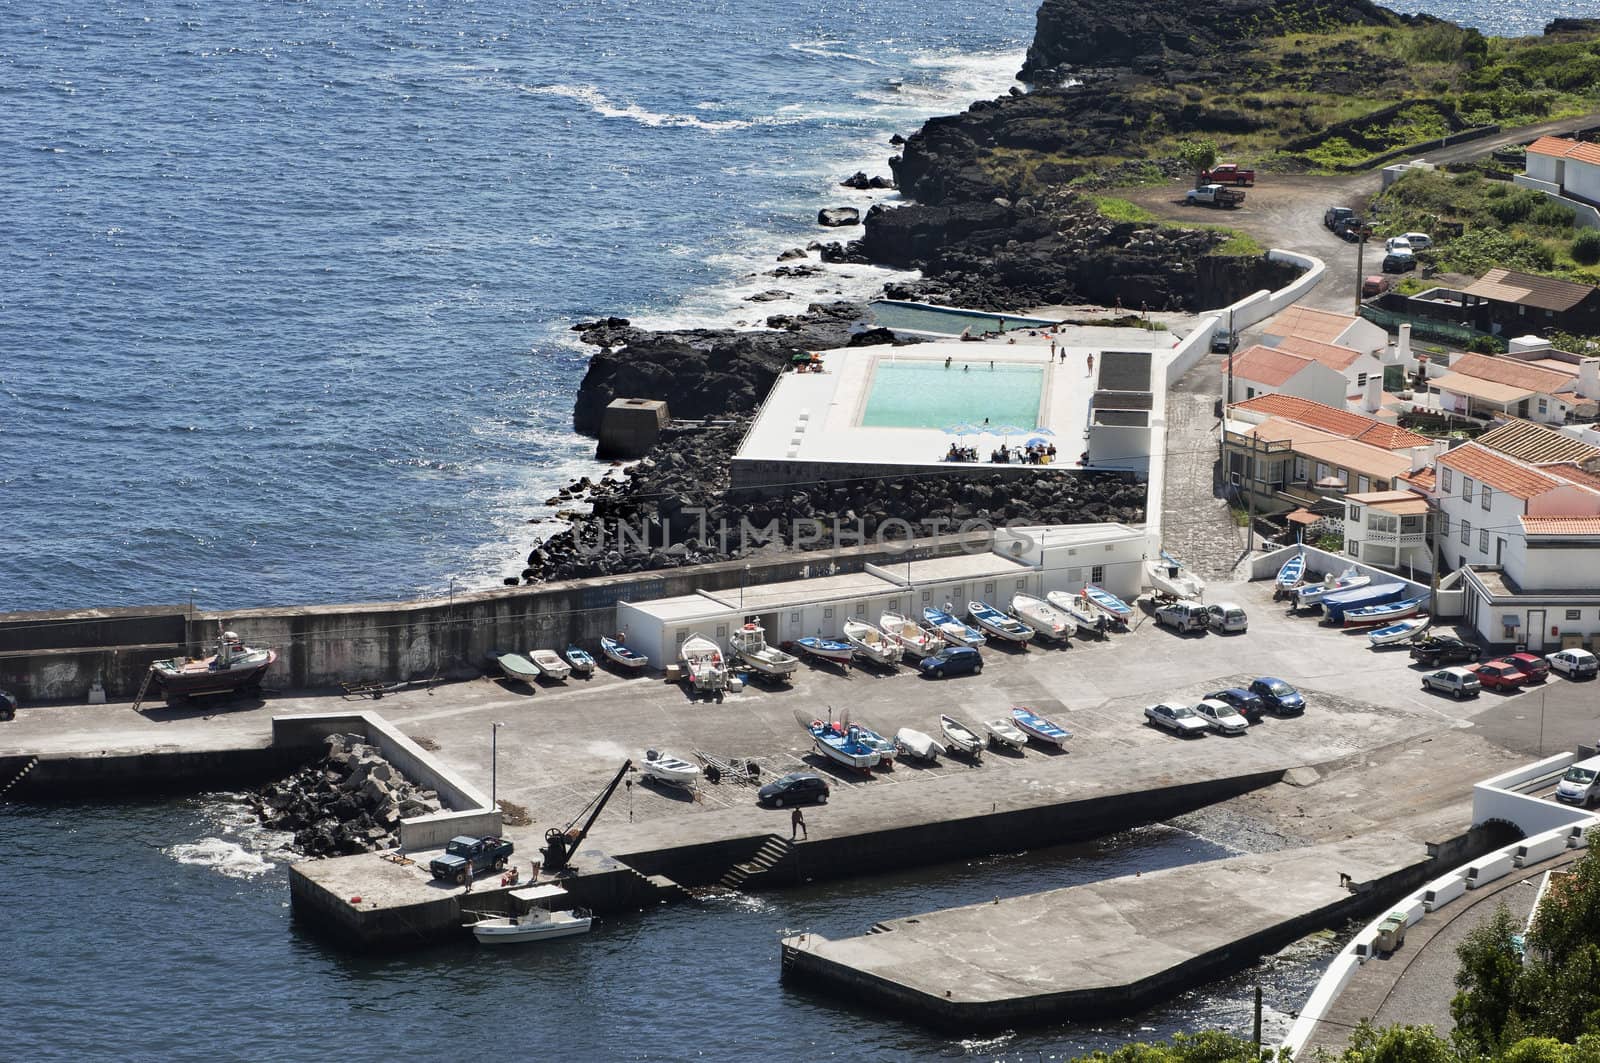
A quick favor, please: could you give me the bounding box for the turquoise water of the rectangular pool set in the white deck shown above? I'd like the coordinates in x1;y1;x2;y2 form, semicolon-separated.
861;359;1045;429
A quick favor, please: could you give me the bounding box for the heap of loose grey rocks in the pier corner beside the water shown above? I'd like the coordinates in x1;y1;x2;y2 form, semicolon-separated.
250;735;440;856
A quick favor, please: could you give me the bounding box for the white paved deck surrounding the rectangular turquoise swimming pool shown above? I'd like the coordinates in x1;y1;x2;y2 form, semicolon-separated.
738;327;1178;469
